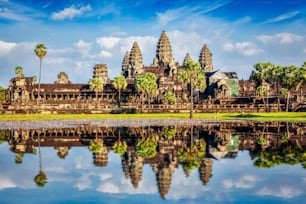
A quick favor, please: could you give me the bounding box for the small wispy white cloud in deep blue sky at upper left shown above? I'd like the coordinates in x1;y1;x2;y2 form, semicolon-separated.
51;5;91;20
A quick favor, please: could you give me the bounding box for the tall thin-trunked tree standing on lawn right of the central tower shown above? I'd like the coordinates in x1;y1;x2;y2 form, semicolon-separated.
178;60;206;118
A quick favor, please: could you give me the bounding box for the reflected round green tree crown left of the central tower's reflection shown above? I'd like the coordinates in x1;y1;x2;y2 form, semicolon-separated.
136;135;158;158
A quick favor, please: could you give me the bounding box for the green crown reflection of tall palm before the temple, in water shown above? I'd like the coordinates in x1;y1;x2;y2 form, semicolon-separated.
178;140;206;170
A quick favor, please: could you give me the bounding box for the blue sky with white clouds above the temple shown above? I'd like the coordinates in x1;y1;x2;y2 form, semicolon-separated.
0;0;306;87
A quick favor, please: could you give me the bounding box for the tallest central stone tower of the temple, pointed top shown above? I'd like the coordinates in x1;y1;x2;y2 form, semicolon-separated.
153;31;174;66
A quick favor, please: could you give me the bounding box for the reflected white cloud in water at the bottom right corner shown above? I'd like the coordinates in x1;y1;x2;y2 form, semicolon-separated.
256;185;303;199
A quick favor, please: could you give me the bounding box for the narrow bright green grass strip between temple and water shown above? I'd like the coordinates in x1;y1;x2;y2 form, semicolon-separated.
0;112;306;122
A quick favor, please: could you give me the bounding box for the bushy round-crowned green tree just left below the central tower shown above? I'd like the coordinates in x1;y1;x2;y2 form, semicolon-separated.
136;72;158;111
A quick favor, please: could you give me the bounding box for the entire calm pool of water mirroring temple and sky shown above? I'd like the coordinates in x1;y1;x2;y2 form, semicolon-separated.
0;119;306;203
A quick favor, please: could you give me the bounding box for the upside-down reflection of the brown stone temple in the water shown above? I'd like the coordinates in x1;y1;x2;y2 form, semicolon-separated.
0;122;306;199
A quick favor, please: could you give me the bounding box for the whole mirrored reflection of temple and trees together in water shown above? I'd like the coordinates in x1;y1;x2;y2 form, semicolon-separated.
0;122;306;199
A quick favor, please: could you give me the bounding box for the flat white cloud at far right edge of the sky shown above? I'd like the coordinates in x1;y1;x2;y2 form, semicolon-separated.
257;33;305;45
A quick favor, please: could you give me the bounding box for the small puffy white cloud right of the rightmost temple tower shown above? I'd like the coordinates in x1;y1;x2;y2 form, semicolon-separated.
222;41;263;56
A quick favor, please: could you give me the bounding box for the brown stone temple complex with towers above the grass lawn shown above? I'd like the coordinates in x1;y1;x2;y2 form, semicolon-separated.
0;31;305;113
